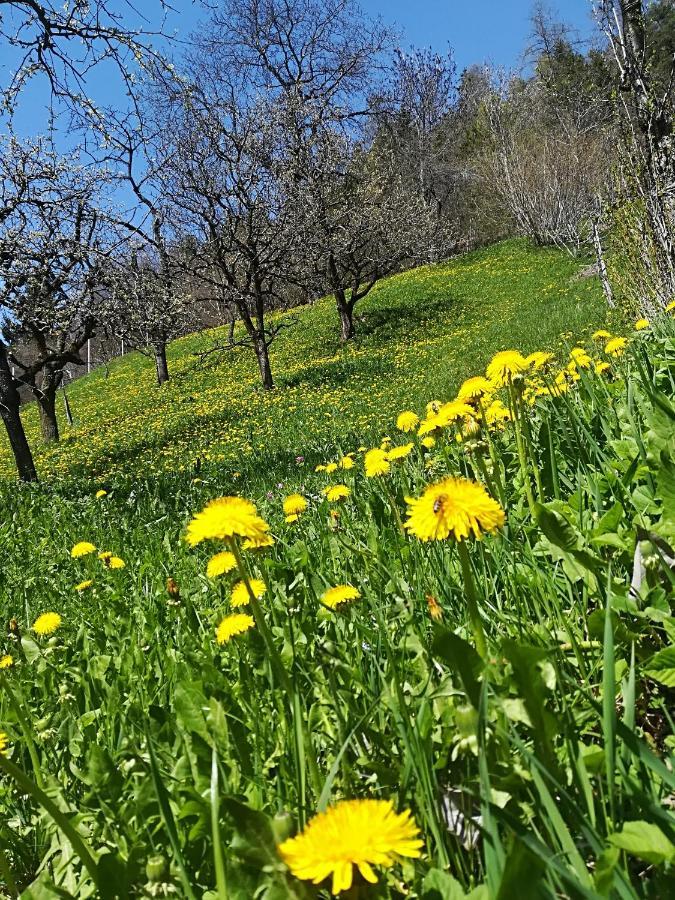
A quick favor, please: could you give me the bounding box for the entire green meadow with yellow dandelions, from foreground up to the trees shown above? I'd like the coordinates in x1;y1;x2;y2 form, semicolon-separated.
0;242;675;900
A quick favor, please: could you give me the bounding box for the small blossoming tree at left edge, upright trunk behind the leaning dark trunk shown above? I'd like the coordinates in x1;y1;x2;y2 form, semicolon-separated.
0;138;109;441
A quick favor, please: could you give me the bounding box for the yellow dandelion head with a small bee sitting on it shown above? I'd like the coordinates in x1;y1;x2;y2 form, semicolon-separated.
405;477;504;541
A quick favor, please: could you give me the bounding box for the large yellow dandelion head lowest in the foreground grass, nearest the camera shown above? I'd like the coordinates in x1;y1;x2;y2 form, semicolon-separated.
279;800;423;894
